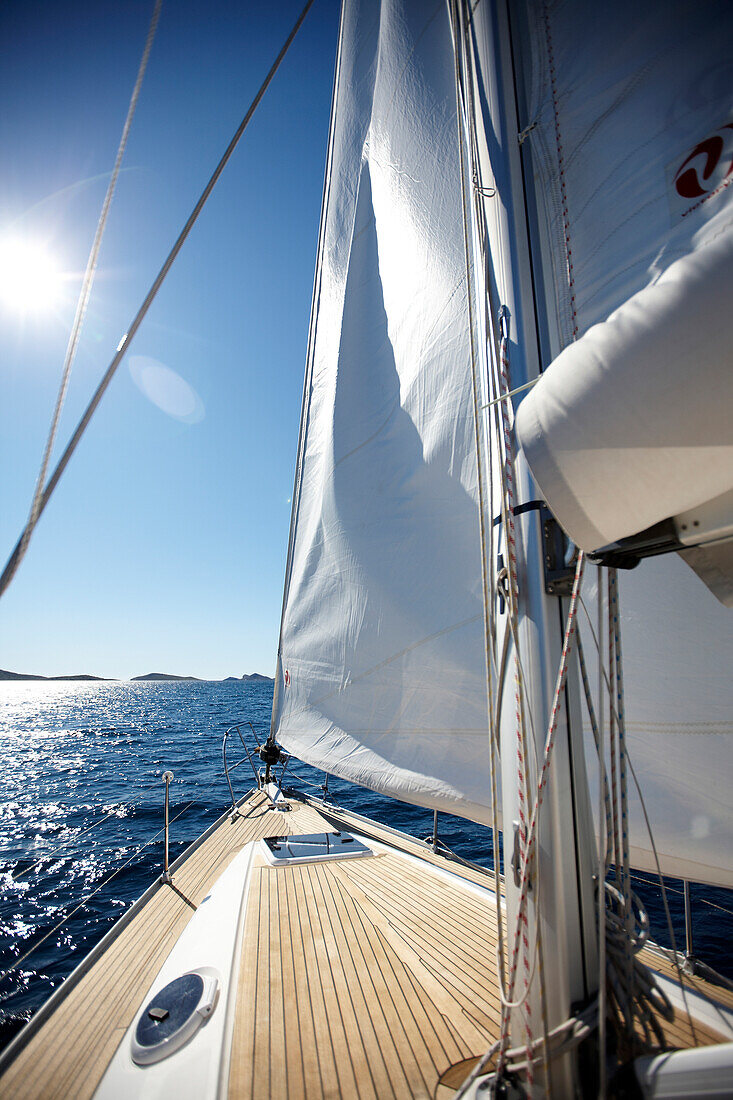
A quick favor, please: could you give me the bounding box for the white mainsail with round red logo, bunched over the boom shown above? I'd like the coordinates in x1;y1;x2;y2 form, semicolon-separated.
517;0;733;550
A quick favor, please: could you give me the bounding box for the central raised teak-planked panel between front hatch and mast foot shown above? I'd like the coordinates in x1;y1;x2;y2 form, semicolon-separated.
229;831;499;1100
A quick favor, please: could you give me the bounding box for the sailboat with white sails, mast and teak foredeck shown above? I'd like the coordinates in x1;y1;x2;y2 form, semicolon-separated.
0;0;733;1098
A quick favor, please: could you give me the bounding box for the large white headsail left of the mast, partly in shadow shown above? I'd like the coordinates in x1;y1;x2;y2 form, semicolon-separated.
268;0;490;822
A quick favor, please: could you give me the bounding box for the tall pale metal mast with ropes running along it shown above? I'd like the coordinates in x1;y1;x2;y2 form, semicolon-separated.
461;0;598;1082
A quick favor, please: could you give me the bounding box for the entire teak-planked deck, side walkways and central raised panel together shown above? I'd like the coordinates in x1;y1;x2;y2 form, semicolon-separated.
0;793;718;1100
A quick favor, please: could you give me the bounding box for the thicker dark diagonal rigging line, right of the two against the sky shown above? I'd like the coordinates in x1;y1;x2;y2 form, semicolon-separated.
0;0;314;596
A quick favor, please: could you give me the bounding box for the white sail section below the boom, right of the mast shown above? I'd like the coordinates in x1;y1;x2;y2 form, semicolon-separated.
579;554;733;888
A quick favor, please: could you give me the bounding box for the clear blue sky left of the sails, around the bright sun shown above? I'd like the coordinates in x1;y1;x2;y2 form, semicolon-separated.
0;0;338;679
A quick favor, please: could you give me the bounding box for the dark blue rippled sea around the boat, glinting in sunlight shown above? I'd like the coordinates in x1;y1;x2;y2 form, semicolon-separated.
0;681;733;1045
